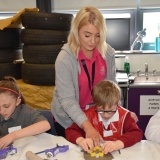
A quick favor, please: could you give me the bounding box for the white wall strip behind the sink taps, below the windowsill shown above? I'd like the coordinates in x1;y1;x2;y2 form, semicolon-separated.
116;53;160;72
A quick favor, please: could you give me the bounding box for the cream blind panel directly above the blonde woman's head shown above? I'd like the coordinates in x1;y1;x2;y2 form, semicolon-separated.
51;0;137;11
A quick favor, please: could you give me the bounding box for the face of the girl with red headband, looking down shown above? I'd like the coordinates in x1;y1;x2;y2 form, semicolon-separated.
0;93;20;118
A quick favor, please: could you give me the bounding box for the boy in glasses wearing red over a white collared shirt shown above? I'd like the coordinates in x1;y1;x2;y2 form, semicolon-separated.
65;80;143;154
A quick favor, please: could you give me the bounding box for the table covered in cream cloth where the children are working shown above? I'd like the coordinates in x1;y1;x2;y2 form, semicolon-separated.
6;133;160;160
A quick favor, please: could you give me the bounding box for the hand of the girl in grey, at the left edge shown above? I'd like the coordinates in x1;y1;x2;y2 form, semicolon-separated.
0;133;14;149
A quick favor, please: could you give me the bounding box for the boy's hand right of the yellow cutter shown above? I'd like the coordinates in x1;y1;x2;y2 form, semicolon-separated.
102;140;124;154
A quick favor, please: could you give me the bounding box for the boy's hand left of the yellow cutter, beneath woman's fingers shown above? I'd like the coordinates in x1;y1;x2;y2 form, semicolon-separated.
76;137;94;152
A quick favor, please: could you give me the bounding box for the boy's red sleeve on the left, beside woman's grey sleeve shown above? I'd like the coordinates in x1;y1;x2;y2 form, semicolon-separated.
65;123;85;144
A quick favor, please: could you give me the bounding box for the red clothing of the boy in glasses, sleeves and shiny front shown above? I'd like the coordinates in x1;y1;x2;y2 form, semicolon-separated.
65;106;143;148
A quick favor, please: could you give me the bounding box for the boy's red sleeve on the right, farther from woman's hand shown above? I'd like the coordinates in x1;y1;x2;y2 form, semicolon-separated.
119;112;143;148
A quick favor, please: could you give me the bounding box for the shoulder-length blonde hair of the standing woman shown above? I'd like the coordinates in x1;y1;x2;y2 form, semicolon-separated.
68;6;107;58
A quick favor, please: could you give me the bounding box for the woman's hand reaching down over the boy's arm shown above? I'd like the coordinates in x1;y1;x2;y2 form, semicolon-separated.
82;120;103;147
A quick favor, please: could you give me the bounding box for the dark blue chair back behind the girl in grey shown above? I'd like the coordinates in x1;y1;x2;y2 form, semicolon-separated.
39;109;56;135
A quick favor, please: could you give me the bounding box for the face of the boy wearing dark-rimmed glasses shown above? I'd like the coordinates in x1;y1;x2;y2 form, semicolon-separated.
97;104;117;120
